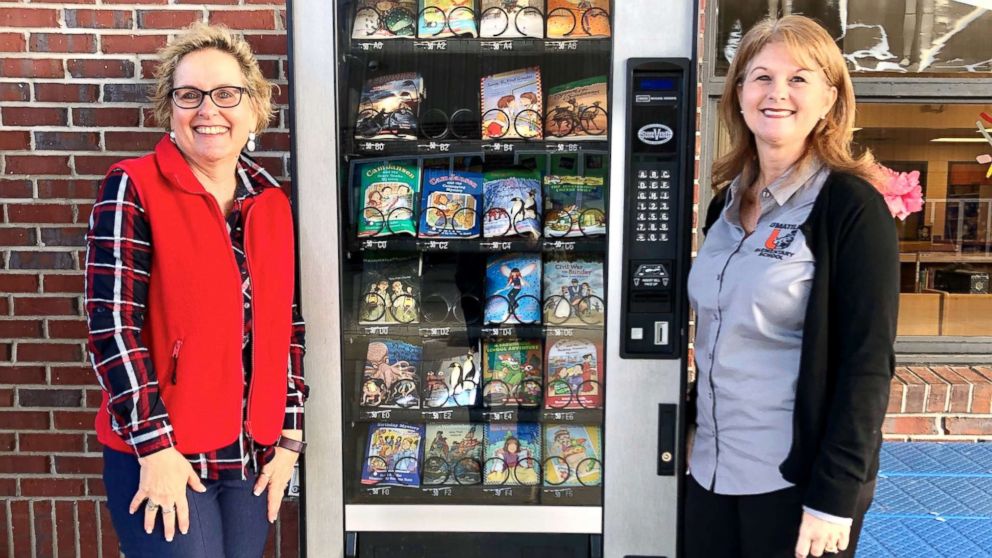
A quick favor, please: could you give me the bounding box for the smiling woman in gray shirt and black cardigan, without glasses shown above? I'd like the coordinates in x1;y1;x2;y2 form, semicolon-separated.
685;16;899;558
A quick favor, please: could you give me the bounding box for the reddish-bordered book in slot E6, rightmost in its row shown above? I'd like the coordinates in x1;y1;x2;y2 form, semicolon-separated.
544;335;604;409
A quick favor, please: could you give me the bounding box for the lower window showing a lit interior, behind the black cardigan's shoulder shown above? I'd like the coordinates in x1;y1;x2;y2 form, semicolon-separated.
717;102;992;336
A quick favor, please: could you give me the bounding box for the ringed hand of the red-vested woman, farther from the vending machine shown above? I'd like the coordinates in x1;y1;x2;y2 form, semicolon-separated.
128;448;207;542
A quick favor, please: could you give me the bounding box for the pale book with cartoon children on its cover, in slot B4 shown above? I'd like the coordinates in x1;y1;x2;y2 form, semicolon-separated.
482;66;544;140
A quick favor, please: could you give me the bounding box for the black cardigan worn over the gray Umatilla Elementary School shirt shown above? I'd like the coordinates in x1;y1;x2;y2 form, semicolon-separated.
689;172;899;517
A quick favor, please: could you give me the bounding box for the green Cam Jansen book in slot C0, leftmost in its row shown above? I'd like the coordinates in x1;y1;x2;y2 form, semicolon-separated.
357;161;420;237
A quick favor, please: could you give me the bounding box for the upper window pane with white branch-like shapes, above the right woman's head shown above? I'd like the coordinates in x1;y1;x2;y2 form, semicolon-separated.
715;0;992;76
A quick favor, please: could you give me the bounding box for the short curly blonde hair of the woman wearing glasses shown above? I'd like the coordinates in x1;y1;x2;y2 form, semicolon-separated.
148;23;275;133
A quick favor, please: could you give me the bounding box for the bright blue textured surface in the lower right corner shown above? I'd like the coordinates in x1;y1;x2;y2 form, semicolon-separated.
858;442;992;558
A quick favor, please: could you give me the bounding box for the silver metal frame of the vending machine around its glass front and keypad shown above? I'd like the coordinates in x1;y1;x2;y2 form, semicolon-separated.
287;0;698;558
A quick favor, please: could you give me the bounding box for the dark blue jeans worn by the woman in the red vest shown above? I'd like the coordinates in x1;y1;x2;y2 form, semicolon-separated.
103;448;270;558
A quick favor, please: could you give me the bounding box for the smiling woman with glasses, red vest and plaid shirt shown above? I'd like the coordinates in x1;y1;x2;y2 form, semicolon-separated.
86;24;308;558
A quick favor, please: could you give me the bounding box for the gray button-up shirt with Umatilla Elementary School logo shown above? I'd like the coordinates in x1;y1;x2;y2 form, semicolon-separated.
689;160;830;495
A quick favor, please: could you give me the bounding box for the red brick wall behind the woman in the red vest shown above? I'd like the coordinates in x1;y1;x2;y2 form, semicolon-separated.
0;0;299;558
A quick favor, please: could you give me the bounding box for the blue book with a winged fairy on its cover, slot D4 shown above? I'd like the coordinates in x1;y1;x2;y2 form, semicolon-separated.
485;253;541;324
